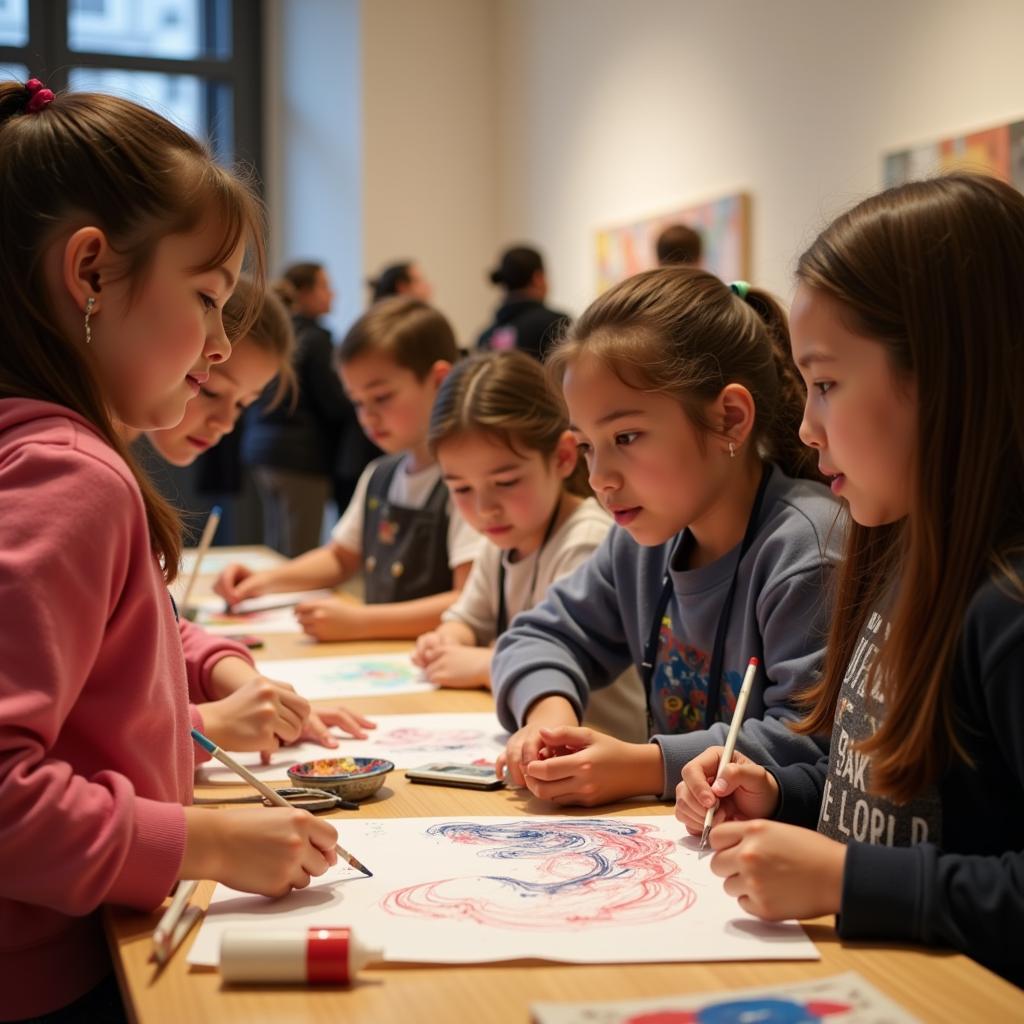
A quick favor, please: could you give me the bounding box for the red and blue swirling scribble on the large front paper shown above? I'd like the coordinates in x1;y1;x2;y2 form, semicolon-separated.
381;818;696;931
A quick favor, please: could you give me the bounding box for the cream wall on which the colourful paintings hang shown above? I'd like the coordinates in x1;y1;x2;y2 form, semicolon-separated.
497;0;1024;312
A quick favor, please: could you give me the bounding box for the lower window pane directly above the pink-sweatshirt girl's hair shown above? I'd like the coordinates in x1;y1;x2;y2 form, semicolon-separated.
68;68;233;164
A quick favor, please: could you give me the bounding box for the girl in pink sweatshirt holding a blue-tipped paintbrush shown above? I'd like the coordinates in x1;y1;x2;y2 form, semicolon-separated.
0;81;337;1021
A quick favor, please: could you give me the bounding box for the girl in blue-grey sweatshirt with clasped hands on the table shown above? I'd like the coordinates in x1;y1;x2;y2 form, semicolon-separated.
492;266;839;805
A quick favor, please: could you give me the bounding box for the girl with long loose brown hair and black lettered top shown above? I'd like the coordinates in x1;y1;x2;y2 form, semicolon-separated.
677;174;1024;985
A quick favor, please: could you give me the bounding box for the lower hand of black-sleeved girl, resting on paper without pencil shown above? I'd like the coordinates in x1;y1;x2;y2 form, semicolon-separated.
711;820;846;921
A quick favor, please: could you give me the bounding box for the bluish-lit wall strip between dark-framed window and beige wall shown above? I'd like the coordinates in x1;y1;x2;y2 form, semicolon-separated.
264;0;365;335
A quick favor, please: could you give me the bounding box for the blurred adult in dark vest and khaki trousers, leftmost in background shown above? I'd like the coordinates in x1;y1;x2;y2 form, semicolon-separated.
242;262;354;557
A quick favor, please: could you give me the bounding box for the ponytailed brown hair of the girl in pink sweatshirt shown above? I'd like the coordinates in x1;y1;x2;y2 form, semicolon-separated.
0;82;263;582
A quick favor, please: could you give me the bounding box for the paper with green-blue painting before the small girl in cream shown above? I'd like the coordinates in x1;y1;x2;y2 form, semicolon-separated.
256;654;436;700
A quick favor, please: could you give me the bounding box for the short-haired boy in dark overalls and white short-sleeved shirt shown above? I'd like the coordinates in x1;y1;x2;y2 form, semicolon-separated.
216;297;480;640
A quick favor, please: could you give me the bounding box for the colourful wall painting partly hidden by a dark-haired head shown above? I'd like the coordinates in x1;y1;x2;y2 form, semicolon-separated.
597;193;751;292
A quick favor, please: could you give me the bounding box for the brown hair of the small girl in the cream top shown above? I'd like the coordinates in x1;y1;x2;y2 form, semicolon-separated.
428;351;592;498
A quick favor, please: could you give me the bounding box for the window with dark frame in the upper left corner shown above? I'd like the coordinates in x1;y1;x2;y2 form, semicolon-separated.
0;0;263;180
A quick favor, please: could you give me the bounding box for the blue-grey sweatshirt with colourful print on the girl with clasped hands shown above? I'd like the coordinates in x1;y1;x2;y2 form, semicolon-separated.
490;466;843;799
